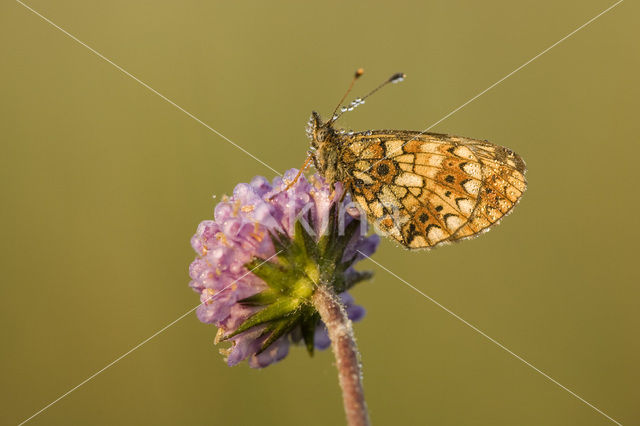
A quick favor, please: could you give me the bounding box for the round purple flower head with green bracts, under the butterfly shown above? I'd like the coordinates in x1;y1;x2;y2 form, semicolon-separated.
189;169;378;368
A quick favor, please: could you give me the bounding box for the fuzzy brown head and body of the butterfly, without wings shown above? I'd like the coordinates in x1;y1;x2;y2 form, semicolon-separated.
307;111;346;185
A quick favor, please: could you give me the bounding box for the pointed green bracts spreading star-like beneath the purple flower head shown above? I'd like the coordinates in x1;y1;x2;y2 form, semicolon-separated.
222;204;372;355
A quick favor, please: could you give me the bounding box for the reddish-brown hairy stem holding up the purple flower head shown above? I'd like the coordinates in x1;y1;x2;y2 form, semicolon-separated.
313;284;369;426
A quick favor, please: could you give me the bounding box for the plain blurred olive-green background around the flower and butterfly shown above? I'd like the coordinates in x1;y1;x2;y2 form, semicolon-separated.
0;0;640;425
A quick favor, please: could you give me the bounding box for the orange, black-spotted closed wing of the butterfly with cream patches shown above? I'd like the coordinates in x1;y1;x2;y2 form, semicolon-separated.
341;130;526;249
